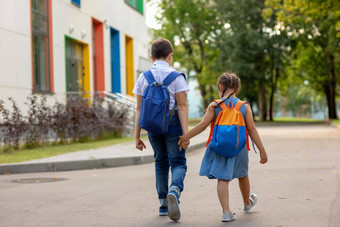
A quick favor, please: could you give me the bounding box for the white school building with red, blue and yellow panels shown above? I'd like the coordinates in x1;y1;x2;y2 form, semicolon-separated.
0;0;152;109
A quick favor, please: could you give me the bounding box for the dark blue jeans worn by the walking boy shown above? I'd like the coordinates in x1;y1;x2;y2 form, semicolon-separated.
148;113;187;199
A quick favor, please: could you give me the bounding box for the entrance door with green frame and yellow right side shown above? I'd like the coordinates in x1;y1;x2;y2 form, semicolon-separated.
66;39;85;94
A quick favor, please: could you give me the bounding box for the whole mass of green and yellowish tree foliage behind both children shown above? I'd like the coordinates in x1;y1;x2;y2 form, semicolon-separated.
155;0;340;120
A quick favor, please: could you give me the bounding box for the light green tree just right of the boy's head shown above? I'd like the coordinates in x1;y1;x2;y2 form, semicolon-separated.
154;0;222;108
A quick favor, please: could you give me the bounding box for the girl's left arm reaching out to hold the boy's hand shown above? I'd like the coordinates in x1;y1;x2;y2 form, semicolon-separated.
178;102;216;149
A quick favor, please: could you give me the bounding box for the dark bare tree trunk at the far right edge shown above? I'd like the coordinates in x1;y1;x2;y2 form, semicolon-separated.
324;54;338;119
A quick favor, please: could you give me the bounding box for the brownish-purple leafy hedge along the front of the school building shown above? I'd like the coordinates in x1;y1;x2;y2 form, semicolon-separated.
0;95;128;152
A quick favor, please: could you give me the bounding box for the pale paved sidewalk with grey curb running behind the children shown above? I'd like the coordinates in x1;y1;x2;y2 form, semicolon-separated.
0;128;209;174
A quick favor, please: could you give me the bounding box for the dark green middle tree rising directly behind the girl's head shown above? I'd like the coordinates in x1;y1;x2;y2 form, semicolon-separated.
216;0;283;121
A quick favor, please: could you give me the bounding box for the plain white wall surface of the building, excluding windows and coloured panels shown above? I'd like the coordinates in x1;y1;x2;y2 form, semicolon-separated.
0;0;150;110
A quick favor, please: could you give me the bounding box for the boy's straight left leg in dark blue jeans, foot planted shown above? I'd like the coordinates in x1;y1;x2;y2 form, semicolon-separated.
148;133;169;207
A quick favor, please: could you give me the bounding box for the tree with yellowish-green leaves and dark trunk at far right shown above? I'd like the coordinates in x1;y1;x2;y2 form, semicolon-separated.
266;0;340;119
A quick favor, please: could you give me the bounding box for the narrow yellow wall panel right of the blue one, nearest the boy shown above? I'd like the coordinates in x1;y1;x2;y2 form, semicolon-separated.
125;36;135;96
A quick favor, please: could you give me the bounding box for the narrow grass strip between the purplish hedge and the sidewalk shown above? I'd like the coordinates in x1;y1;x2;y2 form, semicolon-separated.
0;137;146;164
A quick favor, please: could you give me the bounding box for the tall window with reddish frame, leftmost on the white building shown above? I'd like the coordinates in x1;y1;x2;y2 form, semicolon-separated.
32;0;51;92
